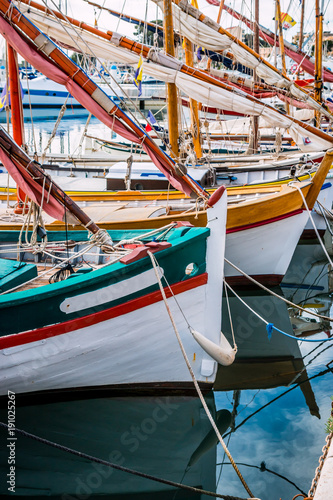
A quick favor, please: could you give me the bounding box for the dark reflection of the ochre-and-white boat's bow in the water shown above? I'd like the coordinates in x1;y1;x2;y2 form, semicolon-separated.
214;289;318;415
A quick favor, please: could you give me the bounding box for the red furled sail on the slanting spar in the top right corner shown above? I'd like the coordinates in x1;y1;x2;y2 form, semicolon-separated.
219;4;333;82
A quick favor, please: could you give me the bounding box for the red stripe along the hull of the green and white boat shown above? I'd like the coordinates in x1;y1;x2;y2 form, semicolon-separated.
0;273;208;349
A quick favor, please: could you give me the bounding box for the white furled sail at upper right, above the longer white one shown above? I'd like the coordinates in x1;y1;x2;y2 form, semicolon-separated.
153;0;333;120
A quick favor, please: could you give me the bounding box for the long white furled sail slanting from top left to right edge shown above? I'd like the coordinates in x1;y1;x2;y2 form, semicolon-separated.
20;4;333;152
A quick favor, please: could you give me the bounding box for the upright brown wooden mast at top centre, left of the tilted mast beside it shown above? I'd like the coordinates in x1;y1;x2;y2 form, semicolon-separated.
163;0;179;157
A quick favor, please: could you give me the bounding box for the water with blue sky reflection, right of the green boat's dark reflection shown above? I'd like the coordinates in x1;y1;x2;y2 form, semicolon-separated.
215;239;333;500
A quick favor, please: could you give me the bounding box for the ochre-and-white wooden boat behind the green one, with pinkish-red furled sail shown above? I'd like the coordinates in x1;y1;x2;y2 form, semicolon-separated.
0;0;332;290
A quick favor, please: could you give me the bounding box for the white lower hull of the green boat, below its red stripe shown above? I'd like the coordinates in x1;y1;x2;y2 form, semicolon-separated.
0;285;217;394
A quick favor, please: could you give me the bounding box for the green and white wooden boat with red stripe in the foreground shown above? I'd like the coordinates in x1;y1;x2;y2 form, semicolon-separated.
0;119;230;395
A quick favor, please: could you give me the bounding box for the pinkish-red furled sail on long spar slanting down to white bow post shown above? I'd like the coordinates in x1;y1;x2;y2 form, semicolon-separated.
0;0;208;198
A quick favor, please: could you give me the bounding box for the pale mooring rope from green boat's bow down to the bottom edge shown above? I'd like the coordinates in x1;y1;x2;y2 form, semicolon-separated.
148;252;254;498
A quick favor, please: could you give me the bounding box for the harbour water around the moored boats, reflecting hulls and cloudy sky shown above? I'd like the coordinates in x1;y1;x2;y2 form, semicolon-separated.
0;114;333;500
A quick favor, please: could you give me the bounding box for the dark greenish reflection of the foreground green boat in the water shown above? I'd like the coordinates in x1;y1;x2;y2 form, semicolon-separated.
0;395;231;500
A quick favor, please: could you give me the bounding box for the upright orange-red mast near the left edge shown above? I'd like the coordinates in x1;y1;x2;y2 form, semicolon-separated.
7;43;26;214
